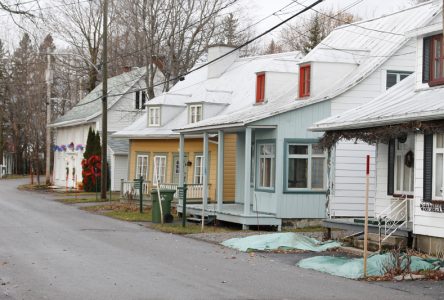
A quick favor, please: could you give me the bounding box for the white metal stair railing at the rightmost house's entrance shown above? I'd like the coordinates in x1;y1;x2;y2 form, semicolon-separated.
376;196;413;251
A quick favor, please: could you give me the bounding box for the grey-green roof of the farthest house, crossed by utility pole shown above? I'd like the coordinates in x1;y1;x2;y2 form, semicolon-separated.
51;67;162;127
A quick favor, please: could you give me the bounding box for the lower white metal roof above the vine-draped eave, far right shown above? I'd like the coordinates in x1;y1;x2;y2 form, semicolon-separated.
310;74;444;131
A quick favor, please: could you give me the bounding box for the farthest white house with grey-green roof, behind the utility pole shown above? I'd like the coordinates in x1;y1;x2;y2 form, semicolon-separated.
50;68;162;190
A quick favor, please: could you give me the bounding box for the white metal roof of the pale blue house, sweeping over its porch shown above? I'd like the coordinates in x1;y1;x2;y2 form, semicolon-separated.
178;1;441;132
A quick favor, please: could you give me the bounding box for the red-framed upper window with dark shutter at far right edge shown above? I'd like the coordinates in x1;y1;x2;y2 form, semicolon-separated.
423;34;444;86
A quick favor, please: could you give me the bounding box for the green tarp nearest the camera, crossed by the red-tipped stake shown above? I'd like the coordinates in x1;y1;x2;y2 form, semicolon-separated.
297;253;439;279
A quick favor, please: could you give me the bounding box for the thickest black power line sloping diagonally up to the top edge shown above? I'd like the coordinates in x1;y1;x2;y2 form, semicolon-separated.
72;0;324;107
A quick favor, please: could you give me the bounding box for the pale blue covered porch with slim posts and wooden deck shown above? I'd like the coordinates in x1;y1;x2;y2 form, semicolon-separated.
177;126;282;230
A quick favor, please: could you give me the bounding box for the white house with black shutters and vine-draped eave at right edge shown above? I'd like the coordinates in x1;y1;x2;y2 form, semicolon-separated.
313;14;444;254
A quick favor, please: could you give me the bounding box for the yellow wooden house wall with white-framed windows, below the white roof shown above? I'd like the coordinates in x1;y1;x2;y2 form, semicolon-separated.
128;134;236;202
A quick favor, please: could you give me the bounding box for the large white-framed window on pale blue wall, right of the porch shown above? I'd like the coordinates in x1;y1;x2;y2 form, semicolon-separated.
285;143;327;191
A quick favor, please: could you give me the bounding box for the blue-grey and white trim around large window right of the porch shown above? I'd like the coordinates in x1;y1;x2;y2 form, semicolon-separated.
282;139;328;194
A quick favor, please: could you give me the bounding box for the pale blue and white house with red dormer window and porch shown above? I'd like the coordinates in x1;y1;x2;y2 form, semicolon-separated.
177;3;440;227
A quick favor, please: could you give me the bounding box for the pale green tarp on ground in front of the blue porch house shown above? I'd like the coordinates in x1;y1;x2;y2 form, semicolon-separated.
222;232;341;252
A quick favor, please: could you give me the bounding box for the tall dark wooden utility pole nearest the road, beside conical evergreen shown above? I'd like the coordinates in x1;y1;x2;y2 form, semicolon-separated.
100;0;108;200
